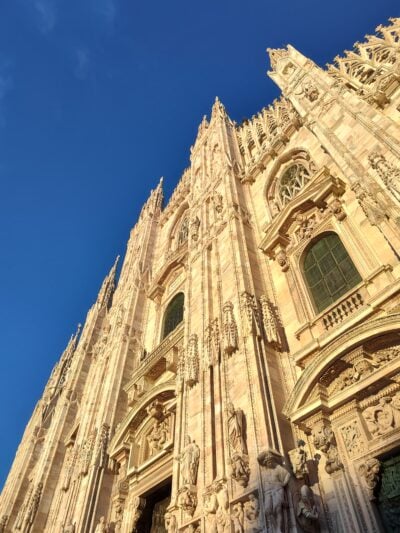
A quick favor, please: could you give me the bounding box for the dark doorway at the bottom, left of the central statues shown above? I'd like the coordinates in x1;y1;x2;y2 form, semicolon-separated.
136;480;171;533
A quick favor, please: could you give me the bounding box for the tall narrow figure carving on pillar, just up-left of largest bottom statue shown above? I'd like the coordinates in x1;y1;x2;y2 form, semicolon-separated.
227;402;250;487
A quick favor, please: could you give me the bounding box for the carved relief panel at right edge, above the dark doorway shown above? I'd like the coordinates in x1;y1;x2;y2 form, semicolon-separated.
362;392;400;437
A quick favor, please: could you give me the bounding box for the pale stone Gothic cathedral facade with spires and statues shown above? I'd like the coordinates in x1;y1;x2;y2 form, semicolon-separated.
0;19;400;533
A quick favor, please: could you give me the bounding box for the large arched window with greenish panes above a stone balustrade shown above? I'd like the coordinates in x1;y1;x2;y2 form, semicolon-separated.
303;233;361;312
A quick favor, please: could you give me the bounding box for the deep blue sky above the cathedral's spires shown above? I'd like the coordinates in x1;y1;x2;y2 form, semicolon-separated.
0;0;400;487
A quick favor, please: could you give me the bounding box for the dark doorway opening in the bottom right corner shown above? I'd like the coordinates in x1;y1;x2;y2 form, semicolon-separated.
377;454;400;533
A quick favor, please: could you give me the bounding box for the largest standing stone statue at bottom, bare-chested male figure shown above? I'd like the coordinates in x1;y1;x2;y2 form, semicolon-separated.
257;450;290;533
